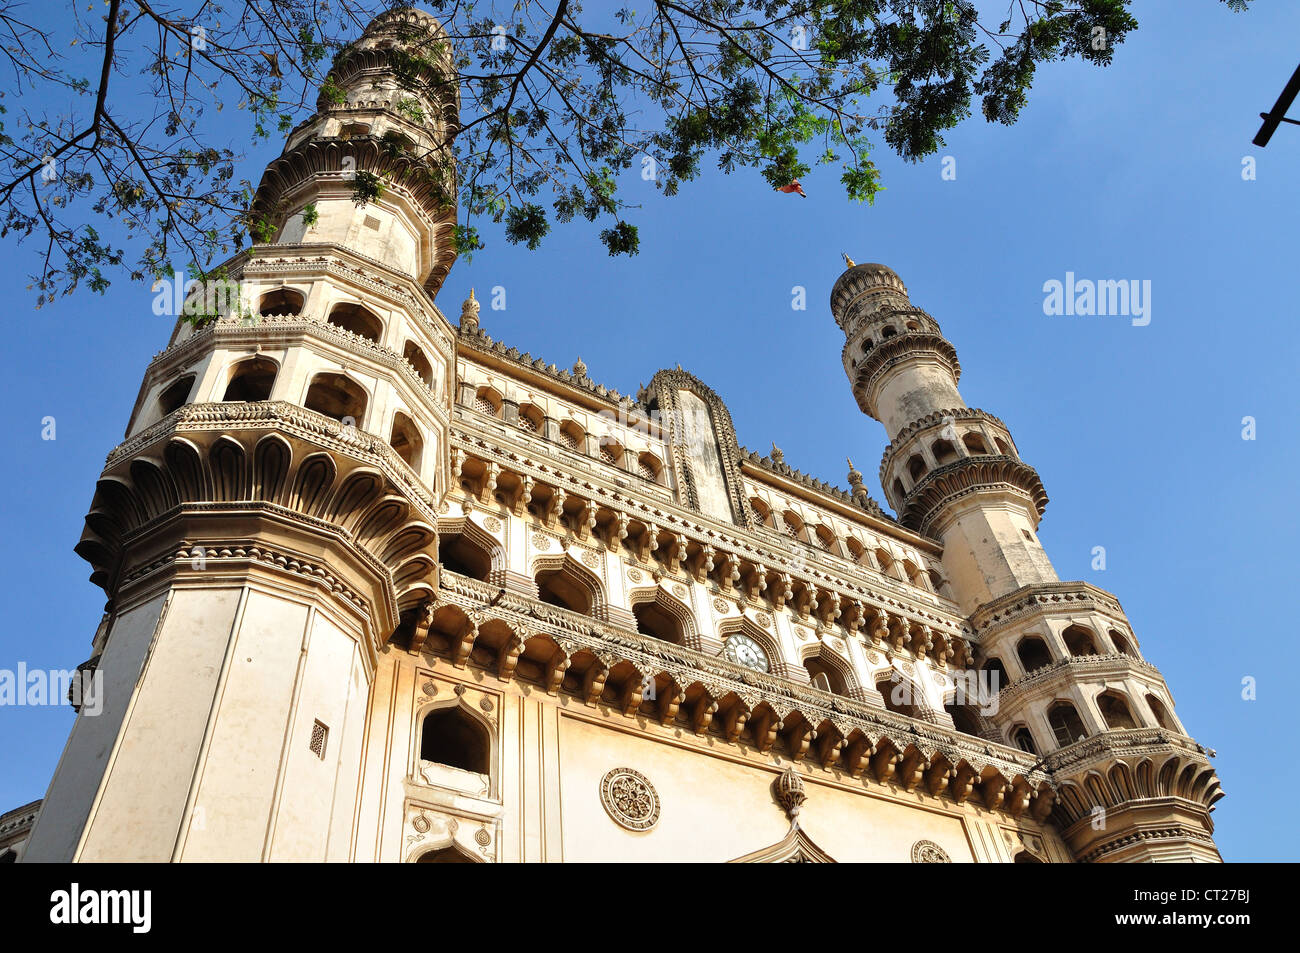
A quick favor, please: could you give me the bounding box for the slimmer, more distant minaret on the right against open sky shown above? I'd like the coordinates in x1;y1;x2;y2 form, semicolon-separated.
831;256;1223;861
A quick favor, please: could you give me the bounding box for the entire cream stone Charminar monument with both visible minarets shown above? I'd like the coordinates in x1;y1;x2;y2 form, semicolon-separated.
9;9;1223;863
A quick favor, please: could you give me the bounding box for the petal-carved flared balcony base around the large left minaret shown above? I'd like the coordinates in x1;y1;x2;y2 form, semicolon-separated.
86;402;437;631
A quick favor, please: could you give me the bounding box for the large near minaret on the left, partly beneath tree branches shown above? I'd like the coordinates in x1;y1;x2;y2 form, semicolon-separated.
25;9;456;861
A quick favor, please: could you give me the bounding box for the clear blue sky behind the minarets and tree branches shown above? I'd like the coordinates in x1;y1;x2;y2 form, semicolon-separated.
0;0;1300;861
